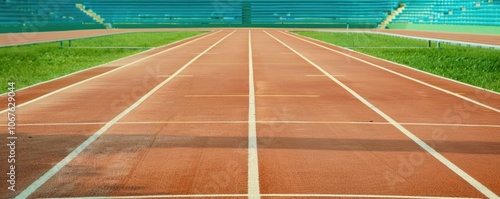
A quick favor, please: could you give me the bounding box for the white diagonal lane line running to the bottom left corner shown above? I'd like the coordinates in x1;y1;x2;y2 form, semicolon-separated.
16;31;235;199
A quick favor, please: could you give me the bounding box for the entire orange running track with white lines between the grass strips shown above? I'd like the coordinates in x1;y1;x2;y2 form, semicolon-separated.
0;29;500;198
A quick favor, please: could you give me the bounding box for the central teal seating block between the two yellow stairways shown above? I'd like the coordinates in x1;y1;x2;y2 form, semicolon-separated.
84;0;397;28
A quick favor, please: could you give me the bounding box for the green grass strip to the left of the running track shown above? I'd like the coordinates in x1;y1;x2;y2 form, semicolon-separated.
0;32;203;93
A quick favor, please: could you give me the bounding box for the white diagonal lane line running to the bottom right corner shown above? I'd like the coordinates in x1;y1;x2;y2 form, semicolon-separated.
264;31;498;198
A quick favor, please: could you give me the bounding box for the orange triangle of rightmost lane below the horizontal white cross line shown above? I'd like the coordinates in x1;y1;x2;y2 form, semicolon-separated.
405;126;500;194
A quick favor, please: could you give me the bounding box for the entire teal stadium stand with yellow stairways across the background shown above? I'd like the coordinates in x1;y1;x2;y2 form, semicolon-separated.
0;0;500;32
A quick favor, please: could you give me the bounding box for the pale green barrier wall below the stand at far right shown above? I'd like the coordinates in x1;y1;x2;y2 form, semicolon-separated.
387;23;500;35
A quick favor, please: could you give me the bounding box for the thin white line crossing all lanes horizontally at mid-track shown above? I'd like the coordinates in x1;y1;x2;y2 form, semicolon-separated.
4;120;500;128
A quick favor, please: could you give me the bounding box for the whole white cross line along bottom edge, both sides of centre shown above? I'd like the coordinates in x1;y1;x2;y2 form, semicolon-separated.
42;194;479;199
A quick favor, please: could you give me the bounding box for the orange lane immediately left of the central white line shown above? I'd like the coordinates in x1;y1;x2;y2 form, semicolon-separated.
23;31;248;197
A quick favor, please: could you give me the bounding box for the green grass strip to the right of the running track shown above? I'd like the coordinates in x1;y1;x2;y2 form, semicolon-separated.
295;31;500;92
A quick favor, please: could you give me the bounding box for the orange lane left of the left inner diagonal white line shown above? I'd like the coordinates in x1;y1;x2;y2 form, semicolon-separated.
0;29;230;197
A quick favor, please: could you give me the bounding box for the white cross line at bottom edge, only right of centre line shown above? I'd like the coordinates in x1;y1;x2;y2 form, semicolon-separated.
262;194;478;199
